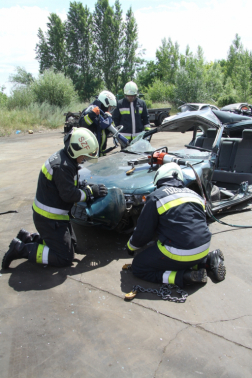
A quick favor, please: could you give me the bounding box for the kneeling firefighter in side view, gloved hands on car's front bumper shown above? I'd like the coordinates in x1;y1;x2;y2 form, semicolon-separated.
2;128;107;269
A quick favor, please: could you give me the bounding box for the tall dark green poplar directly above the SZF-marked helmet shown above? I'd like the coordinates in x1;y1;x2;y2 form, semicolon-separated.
65;1;101;101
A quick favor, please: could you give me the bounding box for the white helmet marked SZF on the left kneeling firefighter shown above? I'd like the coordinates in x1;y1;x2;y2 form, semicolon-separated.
67;127;99;160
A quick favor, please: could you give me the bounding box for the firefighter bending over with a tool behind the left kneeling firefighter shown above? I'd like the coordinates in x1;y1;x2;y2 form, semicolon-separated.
79;91;116;156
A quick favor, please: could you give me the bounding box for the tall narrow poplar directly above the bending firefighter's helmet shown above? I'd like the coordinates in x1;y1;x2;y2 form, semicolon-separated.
93;0;124;92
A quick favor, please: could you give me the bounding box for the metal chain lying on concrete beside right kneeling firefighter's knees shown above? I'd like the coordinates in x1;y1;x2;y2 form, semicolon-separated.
132;284;188;303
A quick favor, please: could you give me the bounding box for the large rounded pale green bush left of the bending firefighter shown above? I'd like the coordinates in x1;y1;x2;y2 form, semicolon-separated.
30;69;77;107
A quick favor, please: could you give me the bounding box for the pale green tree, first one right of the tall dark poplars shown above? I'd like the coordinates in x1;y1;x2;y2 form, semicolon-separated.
156;38;180;84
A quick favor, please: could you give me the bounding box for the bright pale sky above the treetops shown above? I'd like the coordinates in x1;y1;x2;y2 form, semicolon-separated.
0;0;252;95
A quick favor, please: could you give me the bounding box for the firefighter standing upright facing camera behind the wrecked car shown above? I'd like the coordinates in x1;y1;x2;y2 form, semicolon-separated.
113;81;150;141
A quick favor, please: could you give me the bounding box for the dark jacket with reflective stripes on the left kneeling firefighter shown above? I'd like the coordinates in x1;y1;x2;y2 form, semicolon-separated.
33;149;82;220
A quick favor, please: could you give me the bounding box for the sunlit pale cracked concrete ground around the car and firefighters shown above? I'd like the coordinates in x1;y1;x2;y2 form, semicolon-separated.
0;130;252;378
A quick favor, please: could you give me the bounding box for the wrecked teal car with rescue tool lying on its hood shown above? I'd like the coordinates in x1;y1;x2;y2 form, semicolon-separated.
71;108;252;233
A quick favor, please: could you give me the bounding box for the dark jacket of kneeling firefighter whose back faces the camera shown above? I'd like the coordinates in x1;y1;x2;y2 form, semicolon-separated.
128;179;211;261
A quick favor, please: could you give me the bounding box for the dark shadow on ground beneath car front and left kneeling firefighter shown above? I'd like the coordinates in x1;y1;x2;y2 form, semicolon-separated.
1;225;129;291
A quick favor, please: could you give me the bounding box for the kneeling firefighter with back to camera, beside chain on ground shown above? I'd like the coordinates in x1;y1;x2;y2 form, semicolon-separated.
127;163;226;288
